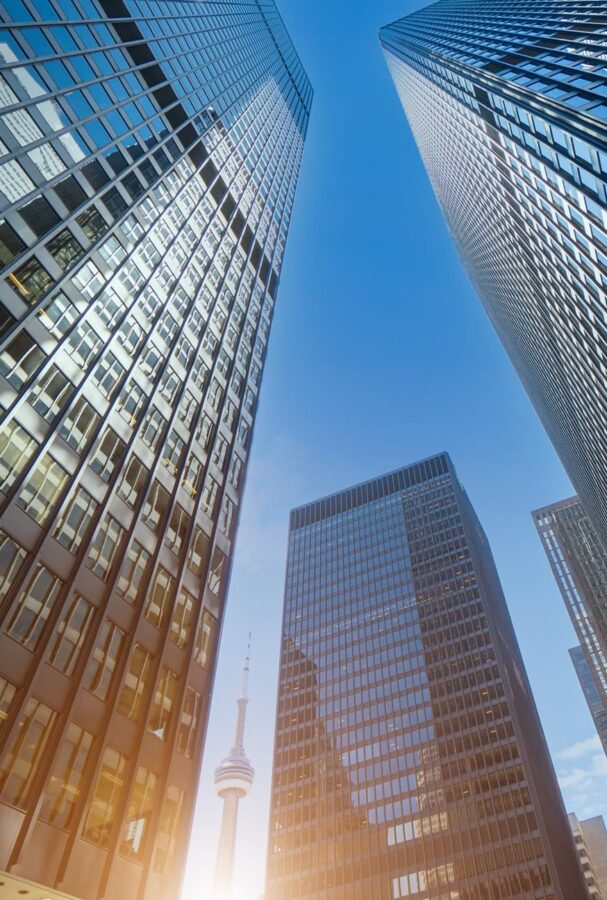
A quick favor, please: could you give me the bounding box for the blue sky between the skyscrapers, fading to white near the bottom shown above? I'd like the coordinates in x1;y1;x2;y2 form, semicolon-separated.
184;0;607;900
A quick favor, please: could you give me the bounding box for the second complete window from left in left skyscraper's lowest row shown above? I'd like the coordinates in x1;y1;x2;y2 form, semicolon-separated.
40;722;93;828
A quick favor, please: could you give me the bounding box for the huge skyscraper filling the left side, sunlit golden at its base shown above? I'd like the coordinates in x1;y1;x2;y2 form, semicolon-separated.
0;0;311;900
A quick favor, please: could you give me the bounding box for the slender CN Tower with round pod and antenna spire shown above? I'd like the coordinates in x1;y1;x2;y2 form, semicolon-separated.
213;635;255;900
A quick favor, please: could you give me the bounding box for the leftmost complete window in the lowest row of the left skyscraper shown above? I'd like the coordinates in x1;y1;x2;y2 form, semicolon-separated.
0;697;57;809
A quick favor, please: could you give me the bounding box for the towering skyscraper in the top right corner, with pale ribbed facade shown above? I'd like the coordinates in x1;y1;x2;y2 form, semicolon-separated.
380;0;607;544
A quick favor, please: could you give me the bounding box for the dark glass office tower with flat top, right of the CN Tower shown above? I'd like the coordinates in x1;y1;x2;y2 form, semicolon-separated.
266;453;586;900
